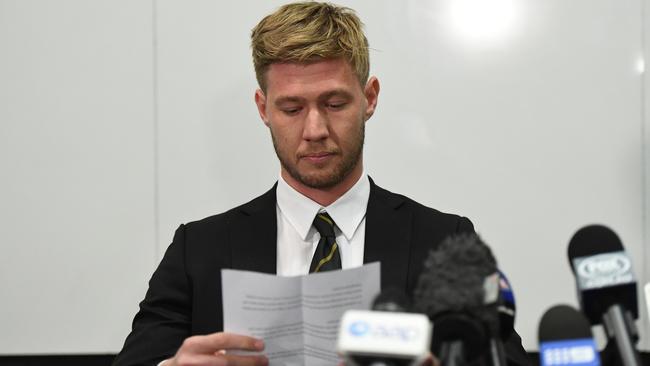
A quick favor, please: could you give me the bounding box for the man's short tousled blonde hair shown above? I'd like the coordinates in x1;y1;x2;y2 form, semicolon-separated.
251;1;370;91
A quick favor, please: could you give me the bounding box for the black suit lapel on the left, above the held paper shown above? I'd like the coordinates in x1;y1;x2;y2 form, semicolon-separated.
229;184;277;273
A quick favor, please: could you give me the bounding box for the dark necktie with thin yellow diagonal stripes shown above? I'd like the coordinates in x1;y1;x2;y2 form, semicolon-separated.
309;212;341;273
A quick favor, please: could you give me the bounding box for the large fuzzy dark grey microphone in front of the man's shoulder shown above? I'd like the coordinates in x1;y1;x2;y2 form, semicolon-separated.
414;234;505;366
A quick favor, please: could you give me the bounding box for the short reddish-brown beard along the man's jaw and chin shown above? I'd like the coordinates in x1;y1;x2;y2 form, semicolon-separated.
271;123;366;189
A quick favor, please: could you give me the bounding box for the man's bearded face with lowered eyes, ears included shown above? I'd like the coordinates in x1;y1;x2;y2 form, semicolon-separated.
255;59;379;189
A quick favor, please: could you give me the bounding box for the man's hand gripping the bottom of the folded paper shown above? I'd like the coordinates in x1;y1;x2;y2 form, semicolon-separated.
161;332;269;366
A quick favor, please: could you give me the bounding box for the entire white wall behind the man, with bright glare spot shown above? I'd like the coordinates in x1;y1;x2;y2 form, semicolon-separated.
0;0;650;354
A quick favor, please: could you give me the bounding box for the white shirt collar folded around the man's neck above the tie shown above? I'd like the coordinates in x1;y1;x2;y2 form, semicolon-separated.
276;172;370;241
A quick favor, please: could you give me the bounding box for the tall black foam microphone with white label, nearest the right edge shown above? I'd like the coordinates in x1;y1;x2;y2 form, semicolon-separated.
568;225;641;366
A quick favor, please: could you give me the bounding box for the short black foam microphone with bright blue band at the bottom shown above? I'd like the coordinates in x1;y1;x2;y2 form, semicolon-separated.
538;305;600;366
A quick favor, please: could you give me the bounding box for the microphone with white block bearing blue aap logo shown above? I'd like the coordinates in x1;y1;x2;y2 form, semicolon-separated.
337;288;431;366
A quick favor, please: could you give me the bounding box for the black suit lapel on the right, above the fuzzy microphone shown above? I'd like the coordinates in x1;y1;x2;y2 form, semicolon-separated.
363;179;412;289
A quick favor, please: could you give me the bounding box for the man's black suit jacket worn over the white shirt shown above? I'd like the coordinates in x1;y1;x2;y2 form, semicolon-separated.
113;180;527;366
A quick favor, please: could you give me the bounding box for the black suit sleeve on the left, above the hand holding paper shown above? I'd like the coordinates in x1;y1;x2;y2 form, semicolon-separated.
113;225;192;366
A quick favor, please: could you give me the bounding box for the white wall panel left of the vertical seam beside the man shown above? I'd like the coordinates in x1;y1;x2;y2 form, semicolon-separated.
0;0;156;354
